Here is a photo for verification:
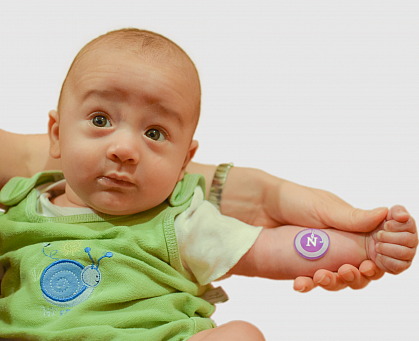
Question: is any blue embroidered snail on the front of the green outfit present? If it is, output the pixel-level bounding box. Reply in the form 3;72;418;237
41;247;113;307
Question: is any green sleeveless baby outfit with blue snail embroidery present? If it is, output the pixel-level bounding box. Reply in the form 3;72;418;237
0;172;215;341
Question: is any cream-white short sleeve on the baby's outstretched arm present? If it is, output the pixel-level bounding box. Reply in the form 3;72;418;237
175;187;262;285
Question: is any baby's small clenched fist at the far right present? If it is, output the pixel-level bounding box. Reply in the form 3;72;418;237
366;205;418;274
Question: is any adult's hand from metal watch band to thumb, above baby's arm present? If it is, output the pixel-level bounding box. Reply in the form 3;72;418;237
220;167;388;232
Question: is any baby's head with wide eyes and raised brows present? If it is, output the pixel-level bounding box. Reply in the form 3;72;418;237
49;29;201;215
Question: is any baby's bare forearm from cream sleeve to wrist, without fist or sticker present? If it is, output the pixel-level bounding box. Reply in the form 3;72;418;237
229;225;367;279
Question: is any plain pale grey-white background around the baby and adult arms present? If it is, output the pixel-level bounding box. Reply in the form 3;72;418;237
0;0;419;340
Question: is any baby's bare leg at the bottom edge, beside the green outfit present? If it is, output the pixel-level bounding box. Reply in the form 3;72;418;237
188;321;265;341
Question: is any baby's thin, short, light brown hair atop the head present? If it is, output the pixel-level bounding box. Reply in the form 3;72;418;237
58;28;201;117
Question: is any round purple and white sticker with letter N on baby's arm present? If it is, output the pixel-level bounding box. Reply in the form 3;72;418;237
294;229;330;260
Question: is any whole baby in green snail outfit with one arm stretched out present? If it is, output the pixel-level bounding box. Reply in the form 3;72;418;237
0;29;417;341
